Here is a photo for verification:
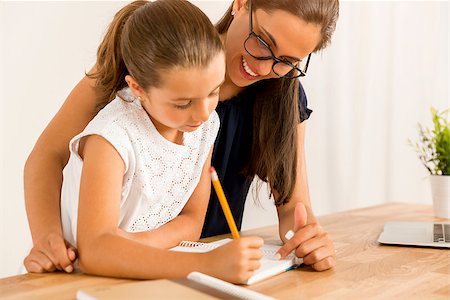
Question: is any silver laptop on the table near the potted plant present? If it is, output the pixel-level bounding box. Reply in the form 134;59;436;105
378;221;450;248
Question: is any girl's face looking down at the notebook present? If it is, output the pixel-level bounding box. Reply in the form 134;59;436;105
133;53;225;139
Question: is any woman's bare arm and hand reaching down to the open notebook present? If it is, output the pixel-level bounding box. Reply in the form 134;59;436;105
274;122;336;271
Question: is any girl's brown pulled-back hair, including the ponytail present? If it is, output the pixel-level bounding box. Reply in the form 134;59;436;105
87;0;223;108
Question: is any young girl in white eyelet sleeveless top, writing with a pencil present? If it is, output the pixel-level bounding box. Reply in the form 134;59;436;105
51;0;262;283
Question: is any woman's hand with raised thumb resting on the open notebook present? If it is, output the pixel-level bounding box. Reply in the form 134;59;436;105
278;203;336;271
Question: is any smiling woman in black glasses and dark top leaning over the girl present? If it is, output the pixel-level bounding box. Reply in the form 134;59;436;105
24;0;339;272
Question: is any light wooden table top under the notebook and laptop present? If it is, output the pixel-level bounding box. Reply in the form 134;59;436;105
0;204;450;300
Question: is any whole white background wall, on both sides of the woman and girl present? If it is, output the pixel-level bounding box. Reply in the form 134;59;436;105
0;1;449;277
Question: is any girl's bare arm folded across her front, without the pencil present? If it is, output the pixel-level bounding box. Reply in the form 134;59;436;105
117;148;212;248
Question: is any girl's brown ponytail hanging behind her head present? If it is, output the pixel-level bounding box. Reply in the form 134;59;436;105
86;1;148;109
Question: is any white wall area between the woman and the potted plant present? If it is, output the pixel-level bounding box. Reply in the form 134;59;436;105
303;1;450;214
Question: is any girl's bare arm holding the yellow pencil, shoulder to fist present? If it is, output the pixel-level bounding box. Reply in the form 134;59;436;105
77;135;262;283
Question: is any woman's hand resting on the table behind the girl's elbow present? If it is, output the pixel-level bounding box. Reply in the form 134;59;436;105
23;233;77;273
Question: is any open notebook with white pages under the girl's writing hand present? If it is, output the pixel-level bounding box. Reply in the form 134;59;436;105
171;238;302;285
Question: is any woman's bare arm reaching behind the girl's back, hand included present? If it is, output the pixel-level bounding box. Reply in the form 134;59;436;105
24;69;100;272
